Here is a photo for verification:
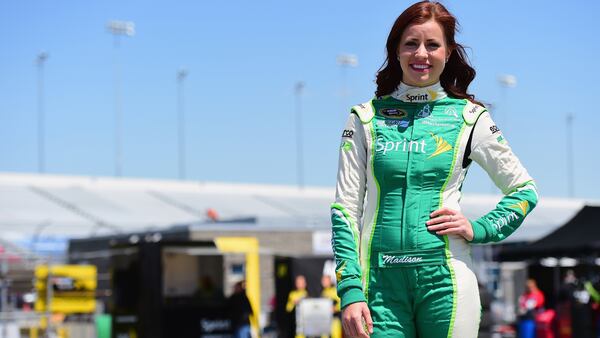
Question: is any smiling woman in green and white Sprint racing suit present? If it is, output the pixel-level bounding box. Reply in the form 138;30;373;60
331;1;537;338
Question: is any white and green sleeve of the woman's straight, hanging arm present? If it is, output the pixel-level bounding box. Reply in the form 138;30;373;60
331;113;367;308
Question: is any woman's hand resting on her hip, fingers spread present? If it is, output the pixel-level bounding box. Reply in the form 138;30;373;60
426;208;473;241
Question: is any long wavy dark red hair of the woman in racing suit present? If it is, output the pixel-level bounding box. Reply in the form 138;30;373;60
375;1;481;104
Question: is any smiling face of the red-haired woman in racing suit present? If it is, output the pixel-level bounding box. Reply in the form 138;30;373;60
398;20;450;87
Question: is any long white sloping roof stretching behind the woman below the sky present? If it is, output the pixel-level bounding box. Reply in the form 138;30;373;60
0;173;586;241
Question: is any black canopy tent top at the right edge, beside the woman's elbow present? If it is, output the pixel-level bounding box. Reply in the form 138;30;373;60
498;206;600;262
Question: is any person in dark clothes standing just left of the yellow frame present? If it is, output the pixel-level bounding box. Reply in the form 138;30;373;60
227;280;253;338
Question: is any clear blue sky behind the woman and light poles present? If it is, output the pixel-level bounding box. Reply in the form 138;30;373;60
0;0;600;199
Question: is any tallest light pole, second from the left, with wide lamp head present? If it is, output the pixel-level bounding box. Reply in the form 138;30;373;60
106;20;135;176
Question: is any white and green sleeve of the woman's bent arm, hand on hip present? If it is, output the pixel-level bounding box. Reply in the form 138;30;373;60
470;112;538;243
